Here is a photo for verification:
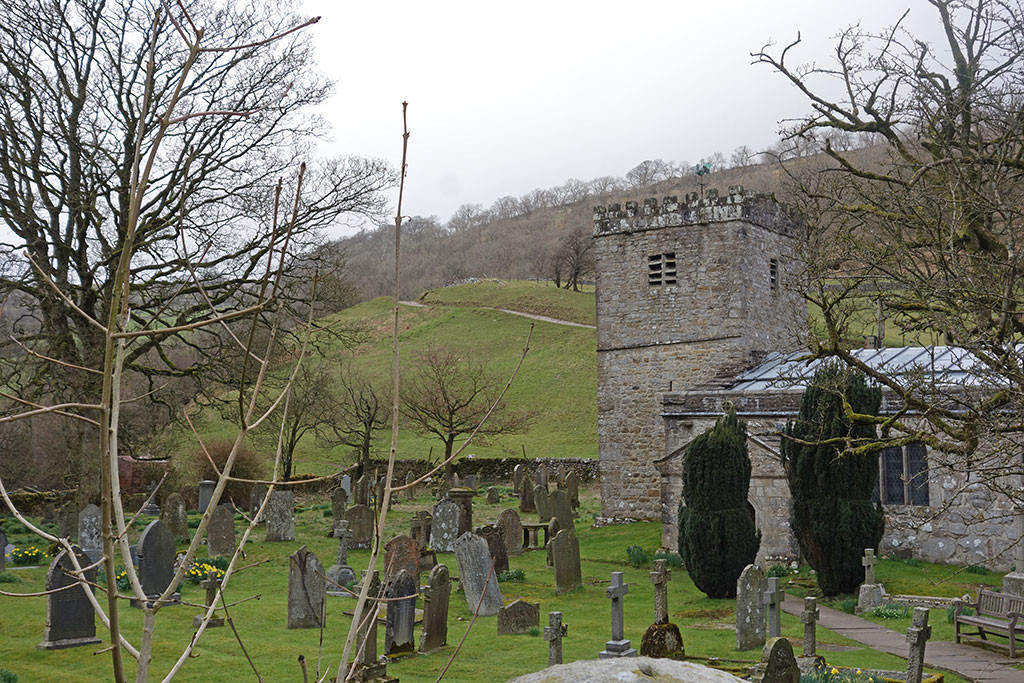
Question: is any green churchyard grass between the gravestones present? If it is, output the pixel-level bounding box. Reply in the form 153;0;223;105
0;486;975;683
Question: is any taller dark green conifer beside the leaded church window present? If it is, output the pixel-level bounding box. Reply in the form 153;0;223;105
781;364;885;596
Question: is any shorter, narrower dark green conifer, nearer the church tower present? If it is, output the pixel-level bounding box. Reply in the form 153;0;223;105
679;411;761;598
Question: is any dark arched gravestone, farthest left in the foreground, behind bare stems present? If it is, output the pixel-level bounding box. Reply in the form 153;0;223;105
36;547;101;650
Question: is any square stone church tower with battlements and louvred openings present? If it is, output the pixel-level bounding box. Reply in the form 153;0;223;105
594;186;807;519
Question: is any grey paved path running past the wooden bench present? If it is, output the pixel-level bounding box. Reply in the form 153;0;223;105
782;595;1024;683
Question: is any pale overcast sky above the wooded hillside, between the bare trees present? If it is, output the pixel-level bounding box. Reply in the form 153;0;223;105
303;0;935;237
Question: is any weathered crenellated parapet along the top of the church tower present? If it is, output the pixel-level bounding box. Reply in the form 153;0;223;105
594;185;802;237
